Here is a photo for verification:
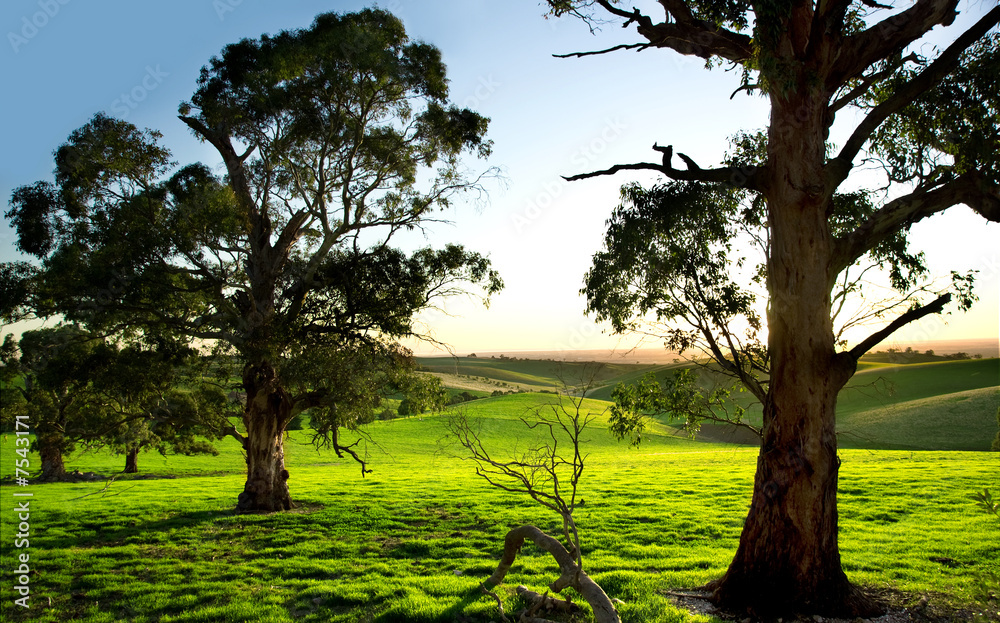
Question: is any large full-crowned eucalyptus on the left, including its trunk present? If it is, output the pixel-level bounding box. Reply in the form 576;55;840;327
2;9;501;511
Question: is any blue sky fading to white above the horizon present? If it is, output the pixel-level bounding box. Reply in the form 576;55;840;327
0;0;1000;352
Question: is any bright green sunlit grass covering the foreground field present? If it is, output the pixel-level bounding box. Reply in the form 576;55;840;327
0;396;1000;623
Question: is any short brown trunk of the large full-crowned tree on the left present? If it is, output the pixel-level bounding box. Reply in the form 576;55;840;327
236;361;294;512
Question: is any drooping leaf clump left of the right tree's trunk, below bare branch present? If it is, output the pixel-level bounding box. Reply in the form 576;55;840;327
583;183;756;342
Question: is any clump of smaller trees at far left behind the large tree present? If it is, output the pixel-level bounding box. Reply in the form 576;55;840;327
0;325;223;480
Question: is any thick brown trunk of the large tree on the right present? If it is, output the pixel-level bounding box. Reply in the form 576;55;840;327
709;87;874;616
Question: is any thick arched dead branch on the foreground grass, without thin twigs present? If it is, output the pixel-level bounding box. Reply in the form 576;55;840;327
483;525;621;623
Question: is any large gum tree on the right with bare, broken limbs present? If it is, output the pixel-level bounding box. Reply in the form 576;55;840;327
548;0;1000;616
